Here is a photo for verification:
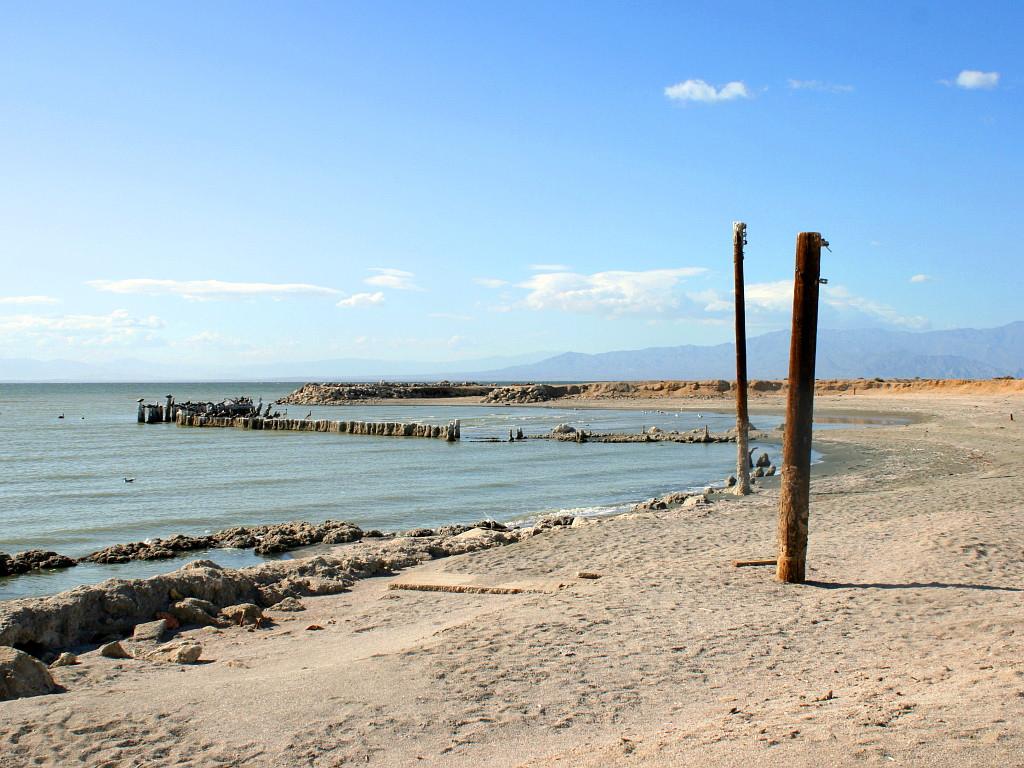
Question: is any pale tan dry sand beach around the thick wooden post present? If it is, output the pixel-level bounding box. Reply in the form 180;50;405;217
0;393;1024;768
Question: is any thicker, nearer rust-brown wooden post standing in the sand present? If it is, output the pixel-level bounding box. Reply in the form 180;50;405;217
775;232;822;584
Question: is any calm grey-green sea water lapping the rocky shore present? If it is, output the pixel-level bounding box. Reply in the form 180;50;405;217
0;383;779;599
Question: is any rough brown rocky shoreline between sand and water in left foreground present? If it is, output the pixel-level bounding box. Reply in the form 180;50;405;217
0;488;711;671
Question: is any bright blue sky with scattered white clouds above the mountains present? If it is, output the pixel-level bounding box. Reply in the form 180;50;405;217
0;2;1024;362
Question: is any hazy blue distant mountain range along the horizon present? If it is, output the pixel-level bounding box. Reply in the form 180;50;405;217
0;322;1024;381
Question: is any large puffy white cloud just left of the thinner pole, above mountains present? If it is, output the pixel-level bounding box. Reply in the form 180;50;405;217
519;267;708;314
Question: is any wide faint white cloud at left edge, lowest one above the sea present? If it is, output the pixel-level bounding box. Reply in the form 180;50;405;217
0;309;164;346
